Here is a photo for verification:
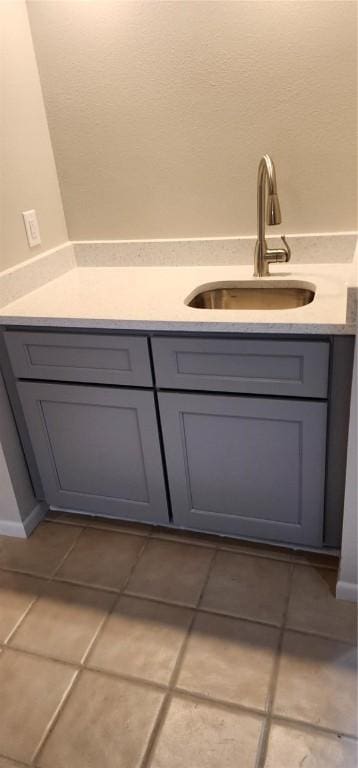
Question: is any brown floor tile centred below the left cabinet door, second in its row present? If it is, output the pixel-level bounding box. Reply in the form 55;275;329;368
56;526;146;589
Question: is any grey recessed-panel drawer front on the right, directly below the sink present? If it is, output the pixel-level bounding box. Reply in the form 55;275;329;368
152;337;329;398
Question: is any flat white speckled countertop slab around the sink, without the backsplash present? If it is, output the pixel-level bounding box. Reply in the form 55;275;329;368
0;262;356;334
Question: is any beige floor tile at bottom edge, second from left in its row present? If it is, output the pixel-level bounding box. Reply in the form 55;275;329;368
39;671;162;768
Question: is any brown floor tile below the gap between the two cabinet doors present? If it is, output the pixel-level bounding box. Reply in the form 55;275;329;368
127;539;213;606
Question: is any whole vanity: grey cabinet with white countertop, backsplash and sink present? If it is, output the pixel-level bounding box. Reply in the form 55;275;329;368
0;236;357;549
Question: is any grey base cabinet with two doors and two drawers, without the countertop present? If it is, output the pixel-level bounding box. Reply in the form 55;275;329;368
2;324;353;548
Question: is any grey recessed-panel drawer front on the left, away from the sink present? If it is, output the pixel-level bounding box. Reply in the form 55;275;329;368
5;331;152;387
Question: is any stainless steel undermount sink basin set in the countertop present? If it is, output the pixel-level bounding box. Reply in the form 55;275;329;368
185;281;315;310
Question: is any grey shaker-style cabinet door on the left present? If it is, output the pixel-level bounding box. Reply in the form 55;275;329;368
17;382;168;523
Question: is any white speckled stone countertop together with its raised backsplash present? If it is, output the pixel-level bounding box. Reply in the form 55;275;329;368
0;234;358;334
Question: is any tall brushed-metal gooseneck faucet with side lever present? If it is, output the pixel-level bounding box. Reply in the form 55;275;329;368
254;155;291;277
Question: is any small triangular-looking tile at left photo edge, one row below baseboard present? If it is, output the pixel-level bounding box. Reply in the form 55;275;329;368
0;571;44;643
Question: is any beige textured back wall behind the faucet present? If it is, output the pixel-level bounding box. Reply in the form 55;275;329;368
28;0;356;239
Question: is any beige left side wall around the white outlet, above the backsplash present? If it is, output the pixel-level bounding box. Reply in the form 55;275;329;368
0;0;68;270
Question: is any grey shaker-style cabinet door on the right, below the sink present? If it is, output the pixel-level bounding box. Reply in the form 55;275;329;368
159;393;326;546
